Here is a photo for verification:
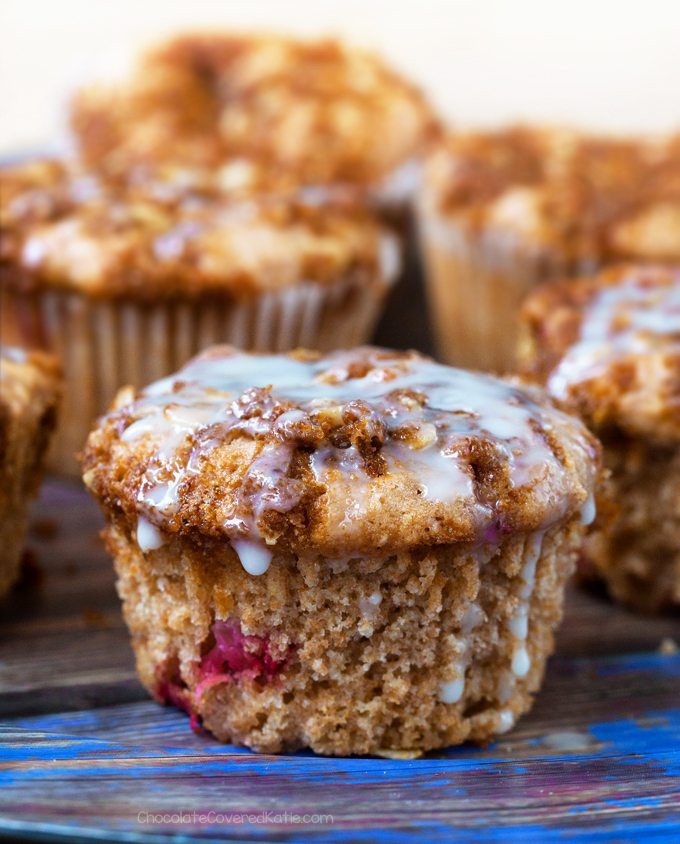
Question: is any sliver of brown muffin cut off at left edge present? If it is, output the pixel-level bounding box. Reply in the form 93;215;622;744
0;346;59;597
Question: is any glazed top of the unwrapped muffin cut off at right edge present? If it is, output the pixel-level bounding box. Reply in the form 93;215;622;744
521;265;680;442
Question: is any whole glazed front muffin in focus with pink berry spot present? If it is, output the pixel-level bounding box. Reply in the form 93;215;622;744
83;347;599;754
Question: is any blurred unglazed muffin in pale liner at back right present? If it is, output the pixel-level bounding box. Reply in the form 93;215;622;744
419;127;680;372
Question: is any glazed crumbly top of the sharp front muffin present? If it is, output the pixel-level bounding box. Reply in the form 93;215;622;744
83;346;599;573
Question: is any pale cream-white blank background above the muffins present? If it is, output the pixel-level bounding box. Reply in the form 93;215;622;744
0;0;680;152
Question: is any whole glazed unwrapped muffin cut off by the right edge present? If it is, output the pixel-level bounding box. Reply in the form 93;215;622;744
521;264;680;612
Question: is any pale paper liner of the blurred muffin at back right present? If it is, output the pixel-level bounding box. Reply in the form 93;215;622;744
418;211;576;372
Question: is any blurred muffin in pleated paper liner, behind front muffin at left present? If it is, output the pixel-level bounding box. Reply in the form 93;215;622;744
0;161;400;472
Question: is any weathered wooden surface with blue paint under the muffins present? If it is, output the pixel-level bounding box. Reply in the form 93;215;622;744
0;483;680;842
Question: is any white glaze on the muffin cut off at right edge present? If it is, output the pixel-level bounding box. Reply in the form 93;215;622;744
548;276;680;399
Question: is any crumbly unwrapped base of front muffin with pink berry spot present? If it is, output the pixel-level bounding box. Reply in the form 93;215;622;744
107;520;582;755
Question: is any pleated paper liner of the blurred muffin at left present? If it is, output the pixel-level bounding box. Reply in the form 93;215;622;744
2;271;395;475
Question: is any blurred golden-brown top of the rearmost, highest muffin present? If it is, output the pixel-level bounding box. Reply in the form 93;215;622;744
72;33;436;190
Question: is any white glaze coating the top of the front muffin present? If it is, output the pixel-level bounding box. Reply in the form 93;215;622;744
117;348;587;570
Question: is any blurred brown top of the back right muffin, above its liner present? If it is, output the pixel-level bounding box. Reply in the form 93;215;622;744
423;127;680;265
